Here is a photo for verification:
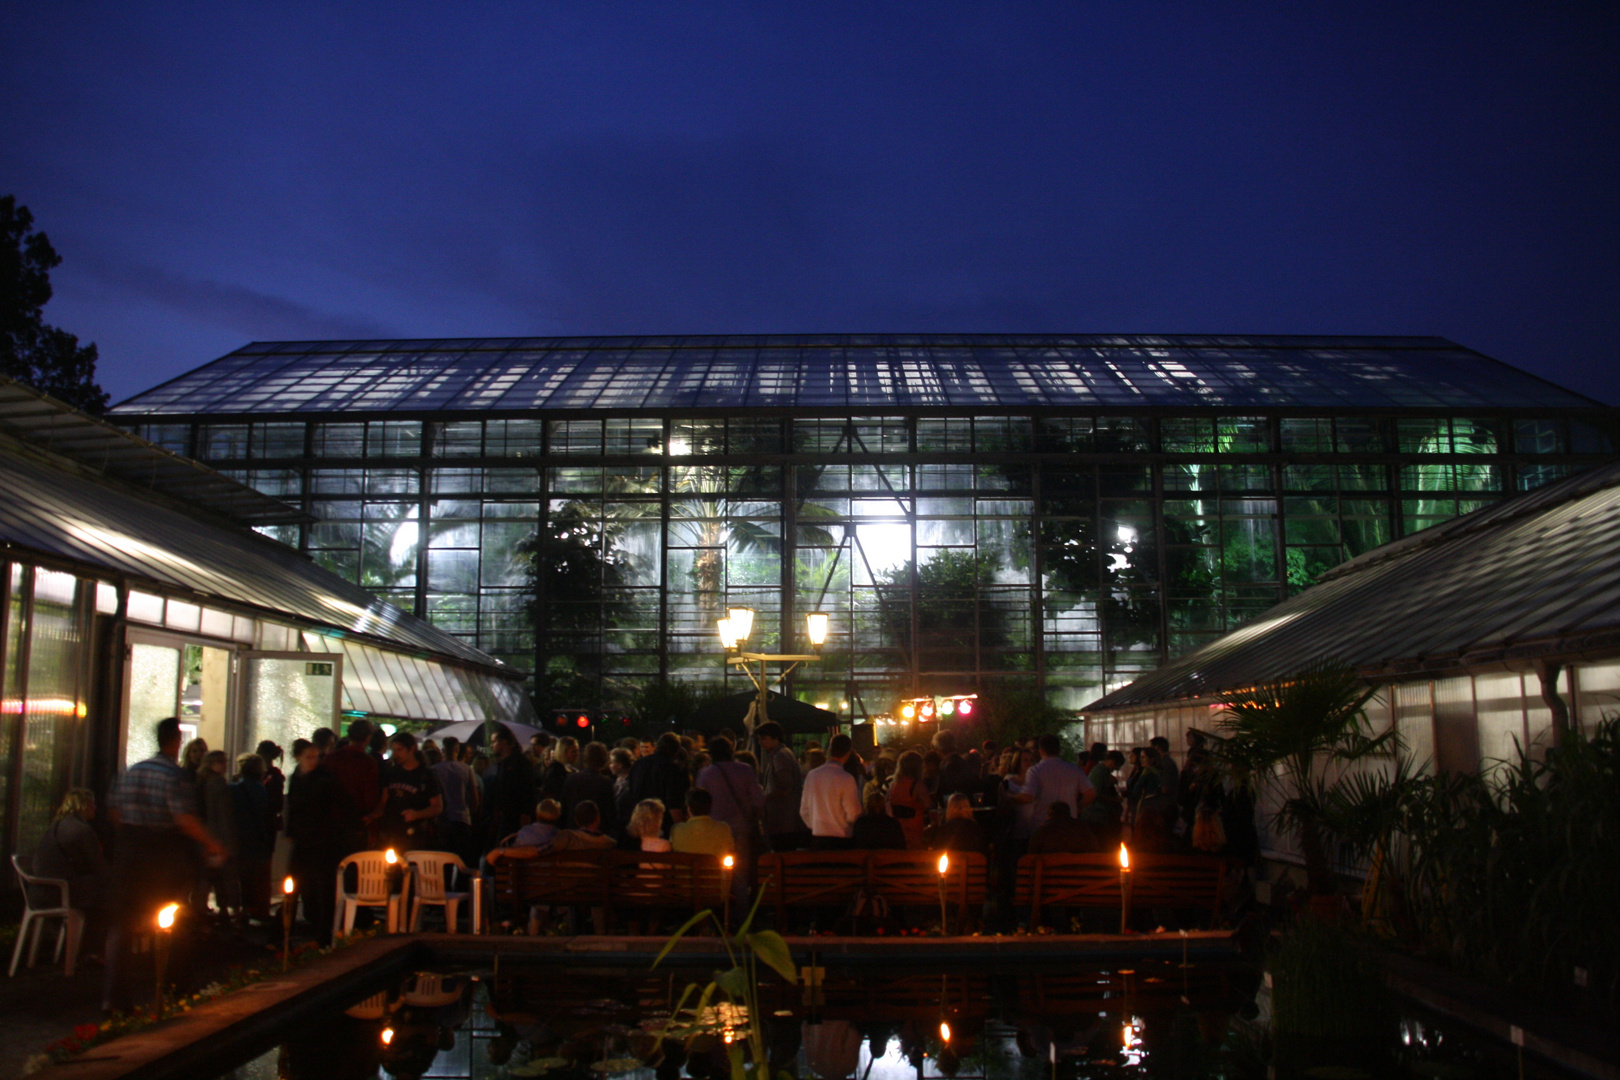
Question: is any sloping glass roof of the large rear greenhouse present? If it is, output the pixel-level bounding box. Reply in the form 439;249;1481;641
112;335;1597;416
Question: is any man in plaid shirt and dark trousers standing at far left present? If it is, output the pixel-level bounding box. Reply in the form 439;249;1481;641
102;716;225;1012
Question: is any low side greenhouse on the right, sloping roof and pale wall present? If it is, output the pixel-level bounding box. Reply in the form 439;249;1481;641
1085;463;1620;772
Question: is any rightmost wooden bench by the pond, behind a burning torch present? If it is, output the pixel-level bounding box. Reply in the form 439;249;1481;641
1013;852;1225;926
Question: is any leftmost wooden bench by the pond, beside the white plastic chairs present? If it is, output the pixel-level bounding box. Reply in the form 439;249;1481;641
494;848;729;913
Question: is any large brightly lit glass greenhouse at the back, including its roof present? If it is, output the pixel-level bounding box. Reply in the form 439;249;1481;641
112;335;1617;717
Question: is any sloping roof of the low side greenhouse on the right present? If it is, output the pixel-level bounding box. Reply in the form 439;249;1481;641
1084;463;1620;712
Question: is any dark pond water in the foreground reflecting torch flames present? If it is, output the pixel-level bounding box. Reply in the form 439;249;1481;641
220;960;1560;1080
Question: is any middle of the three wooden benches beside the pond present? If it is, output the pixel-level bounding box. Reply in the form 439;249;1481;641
755;852;987;926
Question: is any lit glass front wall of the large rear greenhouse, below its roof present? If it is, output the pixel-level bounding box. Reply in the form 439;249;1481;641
144;410;1610;711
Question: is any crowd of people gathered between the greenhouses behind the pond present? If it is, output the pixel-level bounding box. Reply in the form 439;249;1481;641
34;717;1259;1009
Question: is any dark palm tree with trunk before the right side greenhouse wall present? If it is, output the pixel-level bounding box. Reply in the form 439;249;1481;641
1205;661;1396;895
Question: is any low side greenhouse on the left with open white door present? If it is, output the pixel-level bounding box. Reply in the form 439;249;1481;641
0;377;533;882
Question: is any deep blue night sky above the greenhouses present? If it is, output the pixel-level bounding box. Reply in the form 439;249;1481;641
0;0;1620;403
